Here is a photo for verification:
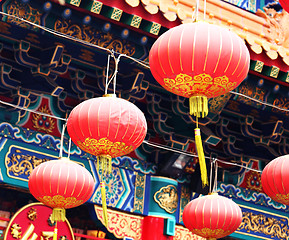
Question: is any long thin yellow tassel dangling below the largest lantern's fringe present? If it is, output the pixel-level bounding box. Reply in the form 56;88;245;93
195;128;208;187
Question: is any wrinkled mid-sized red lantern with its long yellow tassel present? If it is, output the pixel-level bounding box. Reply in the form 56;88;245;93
67;94;147;226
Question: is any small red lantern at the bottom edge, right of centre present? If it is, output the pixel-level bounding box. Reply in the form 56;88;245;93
183;193;242;239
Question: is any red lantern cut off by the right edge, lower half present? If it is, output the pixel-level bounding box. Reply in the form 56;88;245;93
261;155;289;205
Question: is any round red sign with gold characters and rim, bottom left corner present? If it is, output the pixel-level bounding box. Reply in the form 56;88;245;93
4;203;74;240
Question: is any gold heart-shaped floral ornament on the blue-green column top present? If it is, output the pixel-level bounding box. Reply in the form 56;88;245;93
154;185;178;213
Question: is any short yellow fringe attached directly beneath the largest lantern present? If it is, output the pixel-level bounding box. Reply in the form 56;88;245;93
190;96;209;118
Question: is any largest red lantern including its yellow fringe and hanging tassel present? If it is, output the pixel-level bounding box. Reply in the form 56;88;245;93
149;22;250;185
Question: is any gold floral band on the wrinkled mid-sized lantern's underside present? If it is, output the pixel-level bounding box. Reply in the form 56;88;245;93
77;137;133;158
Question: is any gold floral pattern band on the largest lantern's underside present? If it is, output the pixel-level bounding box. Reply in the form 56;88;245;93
164;73;236;98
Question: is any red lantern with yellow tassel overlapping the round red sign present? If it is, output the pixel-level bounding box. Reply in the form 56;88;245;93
28;158;95;238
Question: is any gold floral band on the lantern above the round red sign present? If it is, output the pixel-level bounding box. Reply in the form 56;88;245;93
37;195;83;208
